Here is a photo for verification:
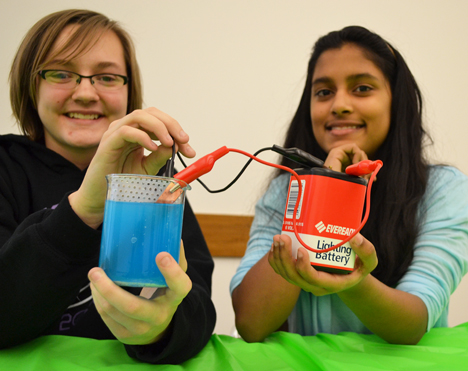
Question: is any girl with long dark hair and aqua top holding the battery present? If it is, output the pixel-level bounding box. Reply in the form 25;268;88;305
231;26;468;344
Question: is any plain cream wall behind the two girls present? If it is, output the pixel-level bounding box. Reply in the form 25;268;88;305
0;0;468;333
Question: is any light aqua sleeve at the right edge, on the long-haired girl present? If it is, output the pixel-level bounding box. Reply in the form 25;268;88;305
397;167;468;330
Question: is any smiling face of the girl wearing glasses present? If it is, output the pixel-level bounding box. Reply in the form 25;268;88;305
37;25;128;168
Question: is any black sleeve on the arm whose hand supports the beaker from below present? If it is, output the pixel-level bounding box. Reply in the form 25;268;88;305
125;202;216;364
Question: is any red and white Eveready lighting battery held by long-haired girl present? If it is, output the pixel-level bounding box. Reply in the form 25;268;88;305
282;168;367;274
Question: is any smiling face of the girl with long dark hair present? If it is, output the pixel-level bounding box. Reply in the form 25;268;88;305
310;44;392;158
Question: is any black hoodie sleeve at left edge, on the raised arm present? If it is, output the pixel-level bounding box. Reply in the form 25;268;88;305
0;195;101;348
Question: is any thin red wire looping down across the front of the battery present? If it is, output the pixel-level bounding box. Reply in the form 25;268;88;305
228;148;382;253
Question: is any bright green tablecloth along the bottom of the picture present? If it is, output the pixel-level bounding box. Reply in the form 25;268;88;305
0;323;468;371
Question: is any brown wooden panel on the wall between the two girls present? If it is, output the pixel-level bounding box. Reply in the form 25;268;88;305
196;214;253;257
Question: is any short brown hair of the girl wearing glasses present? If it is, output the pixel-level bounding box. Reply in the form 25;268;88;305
10;9;143;142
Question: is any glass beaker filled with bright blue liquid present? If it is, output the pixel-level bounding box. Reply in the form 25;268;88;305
99;174;190;287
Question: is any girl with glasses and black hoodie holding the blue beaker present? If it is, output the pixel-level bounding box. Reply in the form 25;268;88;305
0;9;216;363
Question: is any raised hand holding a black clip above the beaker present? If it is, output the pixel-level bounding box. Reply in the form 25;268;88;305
69;107;195;228
